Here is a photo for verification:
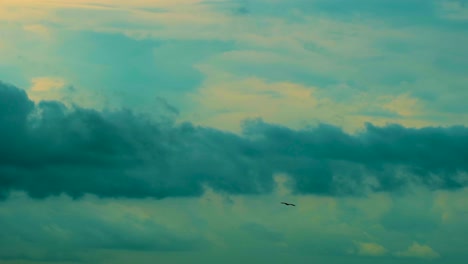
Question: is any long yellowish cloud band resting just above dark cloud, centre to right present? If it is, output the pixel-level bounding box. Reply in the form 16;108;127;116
186;71;434;133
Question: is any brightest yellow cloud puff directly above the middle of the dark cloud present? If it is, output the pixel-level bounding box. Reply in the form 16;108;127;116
186;77;317;134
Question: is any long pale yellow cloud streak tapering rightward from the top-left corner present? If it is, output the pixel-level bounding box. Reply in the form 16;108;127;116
0;0;409;51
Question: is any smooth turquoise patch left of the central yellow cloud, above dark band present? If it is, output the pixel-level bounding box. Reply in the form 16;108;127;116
46;32;233;113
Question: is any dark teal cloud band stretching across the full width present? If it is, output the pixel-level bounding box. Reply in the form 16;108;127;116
0;83;468;198
